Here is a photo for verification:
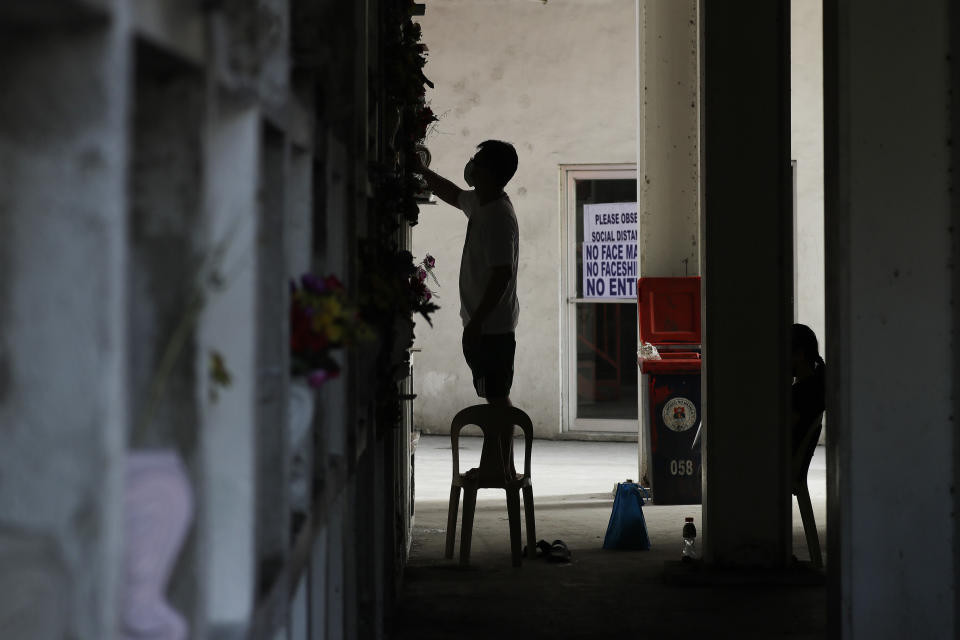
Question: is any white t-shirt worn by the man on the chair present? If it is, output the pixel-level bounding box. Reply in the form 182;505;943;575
457;191;520;333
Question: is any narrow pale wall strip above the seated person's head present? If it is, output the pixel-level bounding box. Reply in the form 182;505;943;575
790;0;826;354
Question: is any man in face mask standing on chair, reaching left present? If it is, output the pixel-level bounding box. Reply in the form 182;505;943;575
421;140;520;477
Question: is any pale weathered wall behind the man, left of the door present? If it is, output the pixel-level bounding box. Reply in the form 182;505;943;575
414;0;637;437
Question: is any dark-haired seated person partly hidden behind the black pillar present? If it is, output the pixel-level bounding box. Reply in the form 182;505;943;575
790;324;826;459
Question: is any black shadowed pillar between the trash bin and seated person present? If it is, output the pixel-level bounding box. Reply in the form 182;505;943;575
701;0;793;568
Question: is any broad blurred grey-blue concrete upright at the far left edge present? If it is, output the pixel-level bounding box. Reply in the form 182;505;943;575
0;7;131;639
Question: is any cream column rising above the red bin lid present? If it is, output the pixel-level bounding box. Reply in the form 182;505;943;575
637;0;700;276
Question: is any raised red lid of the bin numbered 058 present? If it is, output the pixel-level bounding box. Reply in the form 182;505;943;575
637;276;700;344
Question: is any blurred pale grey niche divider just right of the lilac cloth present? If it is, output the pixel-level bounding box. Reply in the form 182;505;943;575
197;100;261;638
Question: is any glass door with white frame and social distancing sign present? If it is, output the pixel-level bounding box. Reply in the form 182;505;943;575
563;165;639;433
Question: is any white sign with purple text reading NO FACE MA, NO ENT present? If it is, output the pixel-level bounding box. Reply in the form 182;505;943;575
583;202;637;298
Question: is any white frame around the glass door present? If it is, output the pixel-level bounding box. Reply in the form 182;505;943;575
559;162;640;434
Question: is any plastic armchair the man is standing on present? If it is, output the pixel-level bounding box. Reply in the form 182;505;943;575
446;404;537;567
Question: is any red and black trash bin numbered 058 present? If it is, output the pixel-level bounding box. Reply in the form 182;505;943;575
637;277;702;504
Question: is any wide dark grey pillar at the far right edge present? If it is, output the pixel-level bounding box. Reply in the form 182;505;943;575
824;0;960;640
